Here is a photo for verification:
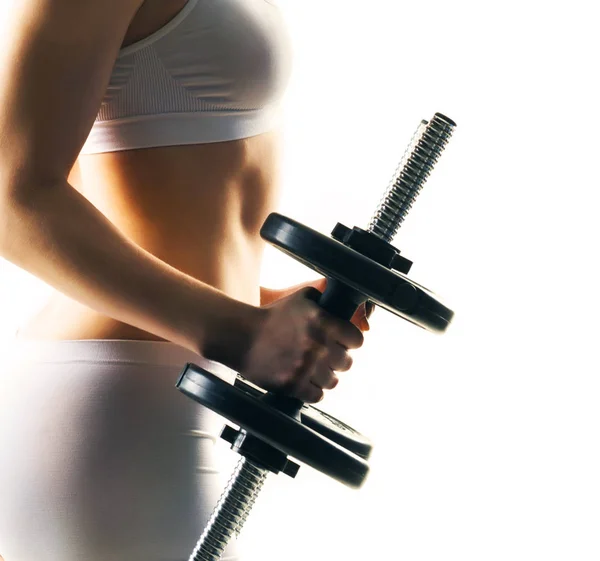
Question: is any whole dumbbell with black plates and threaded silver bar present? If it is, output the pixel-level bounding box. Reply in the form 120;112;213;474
176;113;456;561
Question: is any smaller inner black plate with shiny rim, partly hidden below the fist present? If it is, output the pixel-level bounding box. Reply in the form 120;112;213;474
235;377;373;460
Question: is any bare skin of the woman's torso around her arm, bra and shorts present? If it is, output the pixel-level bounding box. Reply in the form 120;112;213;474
18;0;279;340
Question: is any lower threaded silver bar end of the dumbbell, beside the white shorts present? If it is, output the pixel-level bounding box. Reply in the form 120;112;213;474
189;457;269;561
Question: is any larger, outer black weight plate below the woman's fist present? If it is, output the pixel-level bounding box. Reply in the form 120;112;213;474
176;363;369;488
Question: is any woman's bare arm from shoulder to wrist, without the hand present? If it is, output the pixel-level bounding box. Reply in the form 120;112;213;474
0;0;262;370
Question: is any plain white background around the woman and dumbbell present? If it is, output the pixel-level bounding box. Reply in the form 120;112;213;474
0;0;600;561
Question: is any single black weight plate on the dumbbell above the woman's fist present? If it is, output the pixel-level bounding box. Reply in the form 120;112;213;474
260;213;454;333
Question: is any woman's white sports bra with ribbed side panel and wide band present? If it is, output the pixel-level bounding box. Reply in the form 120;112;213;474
81;0;292;154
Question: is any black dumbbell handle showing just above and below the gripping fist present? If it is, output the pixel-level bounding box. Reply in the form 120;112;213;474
263;278;367;420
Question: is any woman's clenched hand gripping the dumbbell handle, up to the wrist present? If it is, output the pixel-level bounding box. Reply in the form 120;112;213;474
240;286;364;403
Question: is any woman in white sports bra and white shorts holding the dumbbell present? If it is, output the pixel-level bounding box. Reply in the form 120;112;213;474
0;0;368;561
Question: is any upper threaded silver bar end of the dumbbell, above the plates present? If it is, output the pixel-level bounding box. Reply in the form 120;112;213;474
369;113;456;243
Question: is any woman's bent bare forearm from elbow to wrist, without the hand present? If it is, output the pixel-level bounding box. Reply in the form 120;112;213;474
0;177;257;369
